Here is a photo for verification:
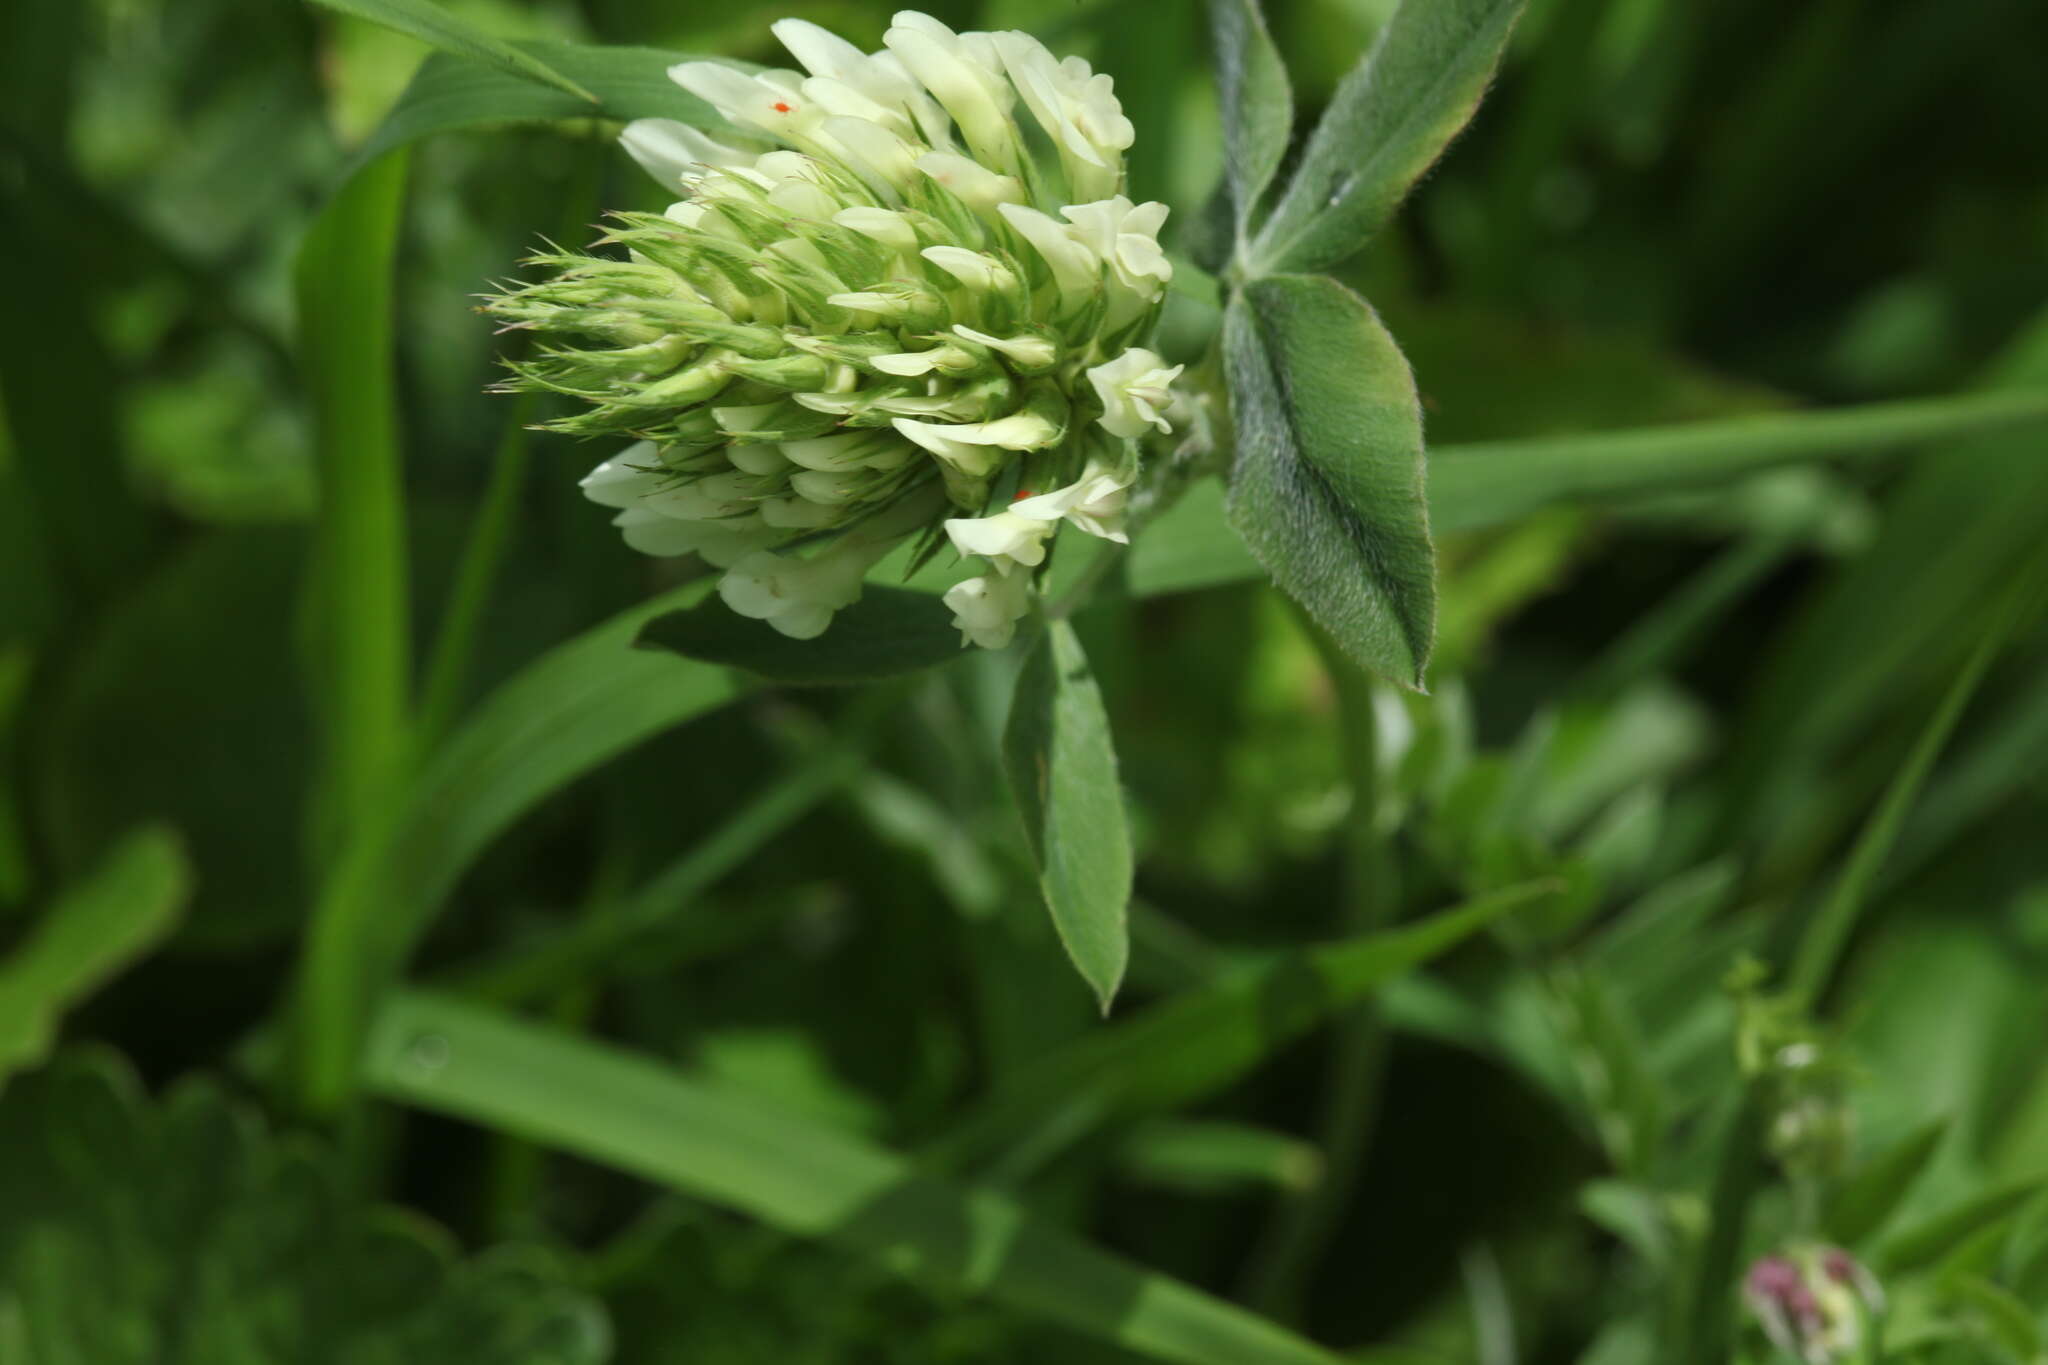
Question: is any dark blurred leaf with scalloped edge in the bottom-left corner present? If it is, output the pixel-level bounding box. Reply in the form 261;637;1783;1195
0;1054;610;1365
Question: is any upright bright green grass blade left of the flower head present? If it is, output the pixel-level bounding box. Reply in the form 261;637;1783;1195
297;153;412;847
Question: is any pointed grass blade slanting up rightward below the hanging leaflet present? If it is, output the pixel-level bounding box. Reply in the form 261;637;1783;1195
940;882;1559;1160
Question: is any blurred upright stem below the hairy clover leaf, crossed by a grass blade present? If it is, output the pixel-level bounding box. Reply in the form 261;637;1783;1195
1245;618;1401;1316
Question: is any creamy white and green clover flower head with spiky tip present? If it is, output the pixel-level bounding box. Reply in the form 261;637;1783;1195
485;10;1180;649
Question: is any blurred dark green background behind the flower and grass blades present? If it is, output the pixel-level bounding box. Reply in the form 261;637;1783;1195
0;0;2048;1365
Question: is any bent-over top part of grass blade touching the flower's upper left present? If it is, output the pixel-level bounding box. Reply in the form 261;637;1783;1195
356;43;727;166
